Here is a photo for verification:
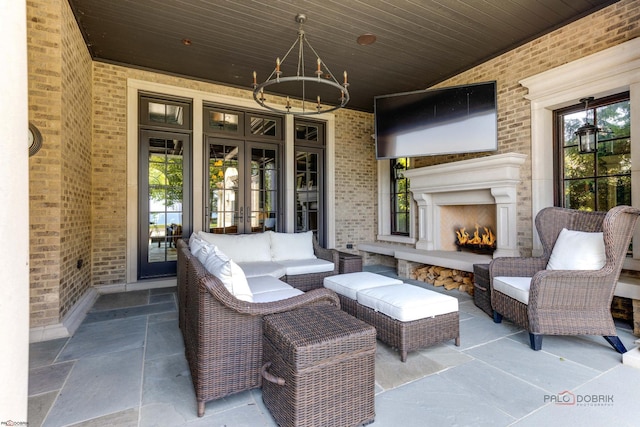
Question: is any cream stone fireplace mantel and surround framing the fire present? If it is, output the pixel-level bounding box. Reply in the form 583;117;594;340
405;153;527;258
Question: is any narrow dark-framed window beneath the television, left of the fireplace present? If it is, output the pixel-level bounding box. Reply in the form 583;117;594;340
390;157;411;236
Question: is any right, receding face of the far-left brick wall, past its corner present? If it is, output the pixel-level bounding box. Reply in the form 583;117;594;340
60;2;92;317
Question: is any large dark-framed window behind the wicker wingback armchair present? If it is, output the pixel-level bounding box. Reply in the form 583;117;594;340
554;92;631;211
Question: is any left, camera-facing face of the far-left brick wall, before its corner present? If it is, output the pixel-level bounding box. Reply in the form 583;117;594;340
27;1;62;326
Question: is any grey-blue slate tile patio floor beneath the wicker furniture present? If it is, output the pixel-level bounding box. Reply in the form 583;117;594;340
29;267;640;427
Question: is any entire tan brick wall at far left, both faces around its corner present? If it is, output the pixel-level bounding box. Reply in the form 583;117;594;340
27;0;91;327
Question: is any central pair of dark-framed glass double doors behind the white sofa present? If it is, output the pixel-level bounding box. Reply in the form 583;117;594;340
205;136;282;234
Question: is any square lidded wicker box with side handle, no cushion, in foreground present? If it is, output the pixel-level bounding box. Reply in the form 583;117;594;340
262;306;376;427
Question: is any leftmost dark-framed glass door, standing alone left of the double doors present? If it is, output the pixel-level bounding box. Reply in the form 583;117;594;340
138;130;192;279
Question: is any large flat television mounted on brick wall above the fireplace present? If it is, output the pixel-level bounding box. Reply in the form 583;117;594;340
374;81;498;159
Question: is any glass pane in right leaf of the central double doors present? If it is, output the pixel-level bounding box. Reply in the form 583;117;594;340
247;144;280;233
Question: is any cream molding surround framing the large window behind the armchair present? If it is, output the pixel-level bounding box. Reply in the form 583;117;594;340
519;38;640;269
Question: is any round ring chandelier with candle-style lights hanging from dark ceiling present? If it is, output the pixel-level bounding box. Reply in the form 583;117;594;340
253;13;349;116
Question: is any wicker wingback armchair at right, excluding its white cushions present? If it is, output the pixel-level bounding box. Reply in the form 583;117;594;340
489;206;640;353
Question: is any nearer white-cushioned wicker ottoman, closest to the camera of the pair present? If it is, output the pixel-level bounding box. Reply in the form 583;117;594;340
357;284;460;362
